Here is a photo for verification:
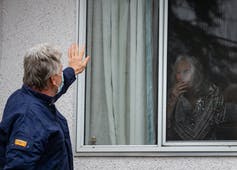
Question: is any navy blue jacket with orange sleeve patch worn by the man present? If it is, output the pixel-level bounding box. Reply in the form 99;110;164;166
0;67;76;170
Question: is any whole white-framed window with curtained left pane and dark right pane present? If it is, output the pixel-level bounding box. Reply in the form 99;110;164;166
76;0;237;155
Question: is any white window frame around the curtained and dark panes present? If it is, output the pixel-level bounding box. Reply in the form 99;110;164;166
74;0;237;156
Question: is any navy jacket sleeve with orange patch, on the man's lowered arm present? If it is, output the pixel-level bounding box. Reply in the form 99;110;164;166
4;115;44;170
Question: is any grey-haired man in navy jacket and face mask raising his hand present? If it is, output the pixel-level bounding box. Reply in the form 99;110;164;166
0;44;90;170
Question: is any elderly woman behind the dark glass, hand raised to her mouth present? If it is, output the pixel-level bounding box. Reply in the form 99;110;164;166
167;55;225;140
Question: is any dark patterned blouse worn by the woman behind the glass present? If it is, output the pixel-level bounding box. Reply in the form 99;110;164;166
171;84;225;140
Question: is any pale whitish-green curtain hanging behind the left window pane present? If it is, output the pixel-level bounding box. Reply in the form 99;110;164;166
85;0;155;145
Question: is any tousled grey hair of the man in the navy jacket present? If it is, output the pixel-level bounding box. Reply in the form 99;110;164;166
23;43;62;90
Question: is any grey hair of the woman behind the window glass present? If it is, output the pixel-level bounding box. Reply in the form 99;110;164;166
172;55;206;93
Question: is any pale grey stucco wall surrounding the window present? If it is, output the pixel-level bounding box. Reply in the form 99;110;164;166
0;0;237;170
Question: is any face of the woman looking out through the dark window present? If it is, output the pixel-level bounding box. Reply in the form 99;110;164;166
175;60;193;83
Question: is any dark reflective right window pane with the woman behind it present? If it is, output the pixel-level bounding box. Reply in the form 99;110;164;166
166;0;237;141
